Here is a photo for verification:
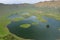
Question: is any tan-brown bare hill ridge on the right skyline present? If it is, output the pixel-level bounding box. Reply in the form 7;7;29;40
34;1;60;7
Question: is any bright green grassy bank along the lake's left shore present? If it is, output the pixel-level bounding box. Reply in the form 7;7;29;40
0;17;10;36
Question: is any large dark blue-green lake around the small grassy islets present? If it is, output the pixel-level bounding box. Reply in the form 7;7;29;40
7;16;60;40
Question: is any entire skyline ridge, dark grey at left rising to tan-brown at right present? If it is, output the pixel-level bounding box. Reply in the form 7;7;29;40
0;1;60;7
